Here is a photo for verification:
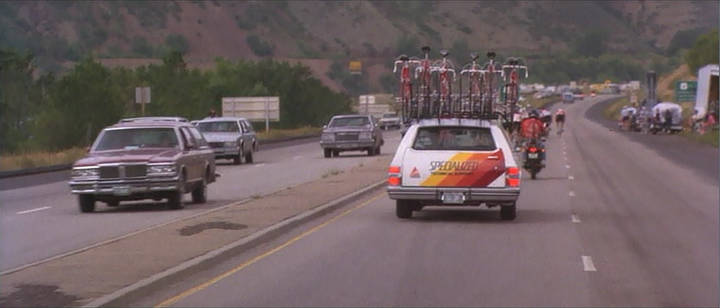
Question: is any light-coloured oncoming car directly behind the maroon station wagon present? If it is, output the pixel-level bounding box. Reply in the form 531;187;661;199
197;117;259;165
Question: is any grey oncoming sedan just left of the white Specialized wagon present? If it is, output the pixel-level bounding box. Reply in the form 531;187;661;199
320;115;385;158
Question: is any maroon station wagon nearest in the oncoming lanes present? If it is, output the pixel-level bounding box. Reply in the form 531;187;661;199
69;121;216;212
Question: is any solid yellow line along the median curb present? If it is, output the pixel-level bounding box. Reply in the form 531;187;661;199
155;192;385;307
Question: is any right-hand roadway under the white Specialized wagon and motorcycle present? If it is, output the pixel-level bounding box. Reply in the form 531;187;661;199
132;98;720;307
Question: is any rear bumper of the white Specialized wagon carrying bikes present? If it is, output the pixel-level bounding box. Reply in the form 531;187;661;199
387;186;520;203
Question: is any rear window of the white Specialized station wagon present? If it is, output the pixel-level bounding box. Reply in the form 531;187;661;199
413;127;496;151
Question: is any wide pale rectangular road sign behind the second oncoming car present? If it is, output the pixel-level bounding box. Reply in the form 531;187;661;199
222;96;280;131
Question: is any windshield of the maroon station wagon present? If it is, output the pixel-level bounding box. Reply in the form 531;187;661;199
95;127;178;151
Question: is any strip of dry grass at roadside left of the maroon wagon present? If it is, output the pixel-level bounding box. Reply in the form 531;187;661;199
0;148;86;171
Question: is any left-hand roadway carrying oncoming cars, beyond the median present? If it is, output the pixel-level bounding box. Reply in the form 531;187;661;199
0;131;400;271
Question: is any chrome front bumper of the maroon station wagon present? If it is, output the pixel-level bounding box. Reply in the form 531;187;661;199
70;177;179;196
